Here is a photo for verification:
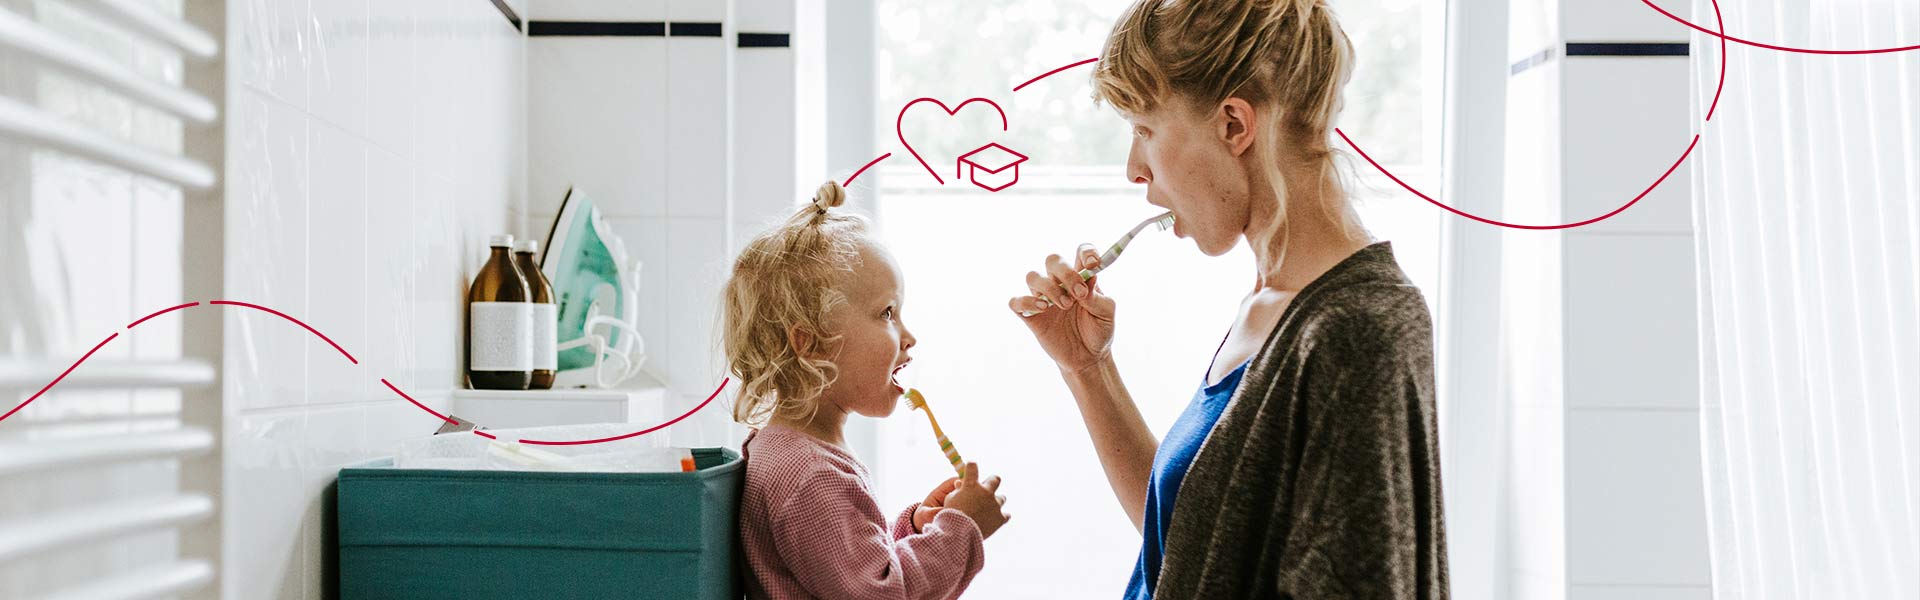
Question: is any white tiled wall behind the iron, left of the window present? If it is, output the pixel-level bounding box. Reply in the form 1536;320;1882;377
526;0;822;446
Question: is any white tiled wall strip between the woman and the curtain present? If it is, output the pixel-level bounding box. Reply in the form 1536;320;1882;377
1503;0;1711;598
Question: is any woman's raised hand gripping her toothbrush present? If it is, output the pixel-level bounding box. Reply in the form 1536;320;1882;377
1008;244;1114;373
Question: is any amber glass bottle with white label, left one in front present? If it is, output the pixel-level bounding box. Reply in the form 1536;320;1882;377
467;235;534;390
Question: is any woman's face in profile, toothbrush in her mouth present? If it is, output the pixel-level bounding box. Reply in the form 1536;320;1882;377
1125;98;1252;256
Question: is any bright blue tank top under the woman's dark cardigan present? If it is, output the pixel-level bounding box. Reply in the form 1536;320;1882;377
1125;362;1252;600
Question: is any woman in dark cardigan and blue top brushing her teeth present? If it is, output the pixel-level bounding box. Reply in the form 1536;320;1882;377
1008;0;1448;598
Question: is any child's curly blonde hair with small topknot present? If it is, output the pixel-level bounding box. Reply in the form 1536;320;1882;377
722;181;870;427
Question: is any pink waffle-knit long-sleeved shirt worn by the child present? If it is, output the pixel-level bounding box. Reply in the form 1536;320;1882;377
739;425;985;600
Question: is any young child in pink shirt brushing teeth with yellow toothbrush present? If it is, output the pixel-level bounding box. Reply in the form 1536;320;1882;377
724;181;1008;598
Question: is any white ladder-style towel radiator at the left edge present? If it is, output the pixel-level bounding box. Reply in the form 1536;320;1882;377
0;0;227;598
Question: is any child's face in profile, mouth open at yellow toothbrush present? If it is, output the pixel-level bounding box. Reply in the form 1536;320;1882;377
824;244;914;417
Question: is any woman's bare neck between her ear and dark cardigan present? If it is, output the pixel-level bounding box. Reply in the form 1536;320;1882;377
1246;171;1373;292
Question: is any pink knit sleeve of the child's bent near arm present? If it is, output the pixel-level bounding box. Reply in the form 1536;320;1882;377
772;477;985;600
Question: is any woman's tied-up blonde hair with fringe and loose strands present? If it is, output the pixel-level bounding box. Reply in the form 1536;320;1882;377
1092;0;1365;265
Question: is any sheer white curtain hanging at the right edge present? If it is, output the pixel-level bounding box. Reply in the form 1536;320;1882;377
1676;0;1920;598
